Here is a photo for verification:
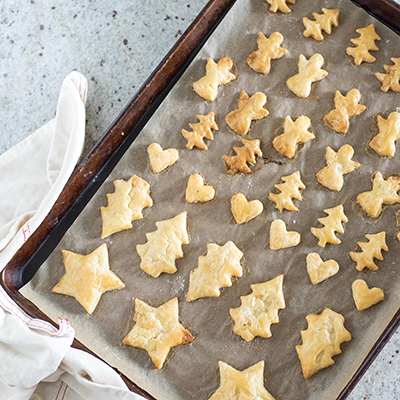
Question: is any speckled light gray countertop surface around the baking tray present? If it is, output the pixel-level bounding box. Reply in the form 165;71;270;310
0;0;400;400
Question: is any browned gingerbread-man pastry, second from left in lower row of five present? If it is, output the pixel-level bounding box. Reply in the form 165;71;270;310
225;90;269;135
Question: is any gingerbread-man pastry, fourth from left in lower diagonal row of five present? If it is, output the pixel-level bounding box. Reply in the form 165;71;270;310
317;144;360;192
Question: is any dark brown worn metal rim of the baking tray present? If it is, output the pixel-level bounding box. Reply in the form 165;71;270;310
0;0;400;400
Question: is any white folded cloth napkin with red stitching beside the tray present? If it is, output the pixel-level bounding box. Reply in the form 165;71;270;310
0;72;143;400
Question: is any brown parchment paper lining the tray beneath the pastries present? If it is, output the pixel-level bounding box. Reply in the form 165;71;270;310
22;0;400;400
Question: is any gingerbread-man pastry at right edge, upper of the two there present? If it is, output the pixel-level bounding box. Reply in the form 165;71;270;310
369;112;400;157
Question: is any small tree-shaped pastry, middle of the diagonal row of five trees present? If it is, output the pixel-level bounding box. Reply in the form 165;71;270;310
268;171;306;212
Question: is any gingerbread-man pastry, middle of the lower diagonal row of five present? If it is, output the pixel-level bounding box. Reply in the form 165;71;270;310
272;115;315;158
